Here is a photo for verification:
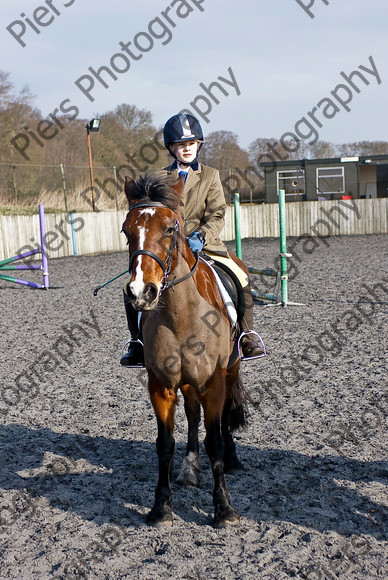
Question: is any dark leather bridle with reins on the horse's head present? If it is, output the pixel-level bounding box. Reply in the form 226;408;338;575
122;201;199;292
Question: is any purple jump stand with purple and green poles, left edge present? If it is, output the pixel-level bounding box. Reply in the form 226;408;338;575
0;205;49;290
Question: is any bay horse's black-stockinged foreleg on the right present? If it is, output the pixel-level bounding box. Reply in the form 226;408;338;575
200;368;240;527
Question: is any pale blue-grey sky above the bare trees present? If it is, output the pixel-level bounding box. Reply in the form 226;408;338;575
0;0;388;148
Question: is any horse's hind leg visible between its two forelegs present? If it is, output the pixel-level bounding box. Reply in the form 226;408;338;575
177;385;201;487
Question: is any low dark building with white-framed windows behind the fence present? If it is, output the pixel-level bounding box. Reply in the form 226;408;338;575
261;155;388;203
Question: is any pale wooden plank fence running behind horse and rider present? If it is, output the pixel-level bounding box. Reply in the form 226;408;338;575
0;198;388;260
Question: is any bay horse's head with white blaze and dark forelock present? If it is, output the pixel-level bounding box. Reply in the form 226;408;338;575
122;174;183;310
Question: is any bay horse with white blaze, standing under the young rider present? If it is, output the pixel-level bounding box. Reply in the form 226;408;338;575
122;173;246;527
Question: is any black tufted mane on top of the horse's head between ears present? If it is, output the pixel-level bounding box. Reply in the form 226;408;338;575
126;173;179;211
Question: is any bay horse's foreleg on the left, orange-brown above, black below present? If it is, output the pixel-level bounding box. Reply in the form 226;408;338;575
147;377;177;526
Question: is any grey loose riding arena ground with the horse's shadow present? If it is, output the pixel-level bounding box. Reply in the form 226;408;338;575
0;236;388;580
